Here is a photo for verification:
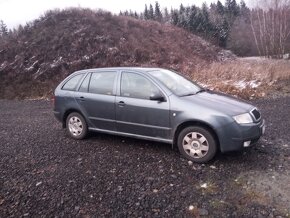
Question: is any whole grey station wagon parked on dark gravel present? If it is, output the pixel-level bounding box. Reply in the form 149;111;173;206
54;68;265;163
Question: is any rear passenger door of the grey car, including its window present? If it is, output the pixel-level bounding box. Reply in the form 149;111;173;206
75;71;117;131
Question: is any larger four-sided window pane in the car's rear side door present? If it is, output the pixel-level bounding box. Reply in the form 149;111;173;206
89;72;116;95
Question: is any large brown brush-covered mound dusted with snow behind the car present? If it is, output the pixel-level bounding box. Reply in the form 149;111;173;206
0;9;228;98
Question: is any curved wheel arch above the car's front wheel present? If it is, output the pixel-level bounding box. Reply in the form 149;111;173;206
173;120;220;150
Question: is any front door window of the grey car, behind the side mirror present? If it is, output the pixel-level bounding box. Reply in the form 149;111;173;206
121;73;160;99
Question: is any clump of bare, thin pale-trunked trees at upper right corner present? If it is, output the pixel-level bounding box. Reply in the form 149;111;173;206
250;0;290;58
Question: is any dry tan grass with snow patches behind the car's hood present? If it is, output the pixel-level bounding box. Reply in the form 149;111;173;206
192;58;290;99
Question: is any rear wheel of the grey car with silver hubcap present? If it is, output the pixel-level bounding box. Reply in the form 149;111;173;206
66;112;88;140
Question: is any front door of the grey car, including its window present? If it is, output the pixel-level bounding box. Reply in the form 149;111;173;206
116;72;171;139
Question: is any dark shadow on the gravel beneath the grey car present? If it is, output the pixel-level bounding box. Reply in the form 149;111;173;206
65;132;269;168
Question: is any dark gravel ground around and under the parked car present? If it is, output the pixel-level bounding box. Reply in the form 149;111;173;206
0;97;290;217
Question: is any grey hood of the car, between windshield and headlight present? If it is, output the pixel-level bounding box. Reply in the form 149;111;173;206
184;92;254;116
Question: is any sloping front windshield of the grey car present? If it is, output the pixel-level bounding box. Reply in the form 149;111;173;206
148;69;202;96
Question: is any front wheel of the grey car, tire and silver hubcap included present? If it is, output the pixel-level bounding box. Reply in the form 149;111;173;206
177;126;217;163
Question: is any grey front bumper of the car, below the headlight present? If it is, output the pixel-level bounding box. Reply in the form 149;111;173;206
217;119;265;152
